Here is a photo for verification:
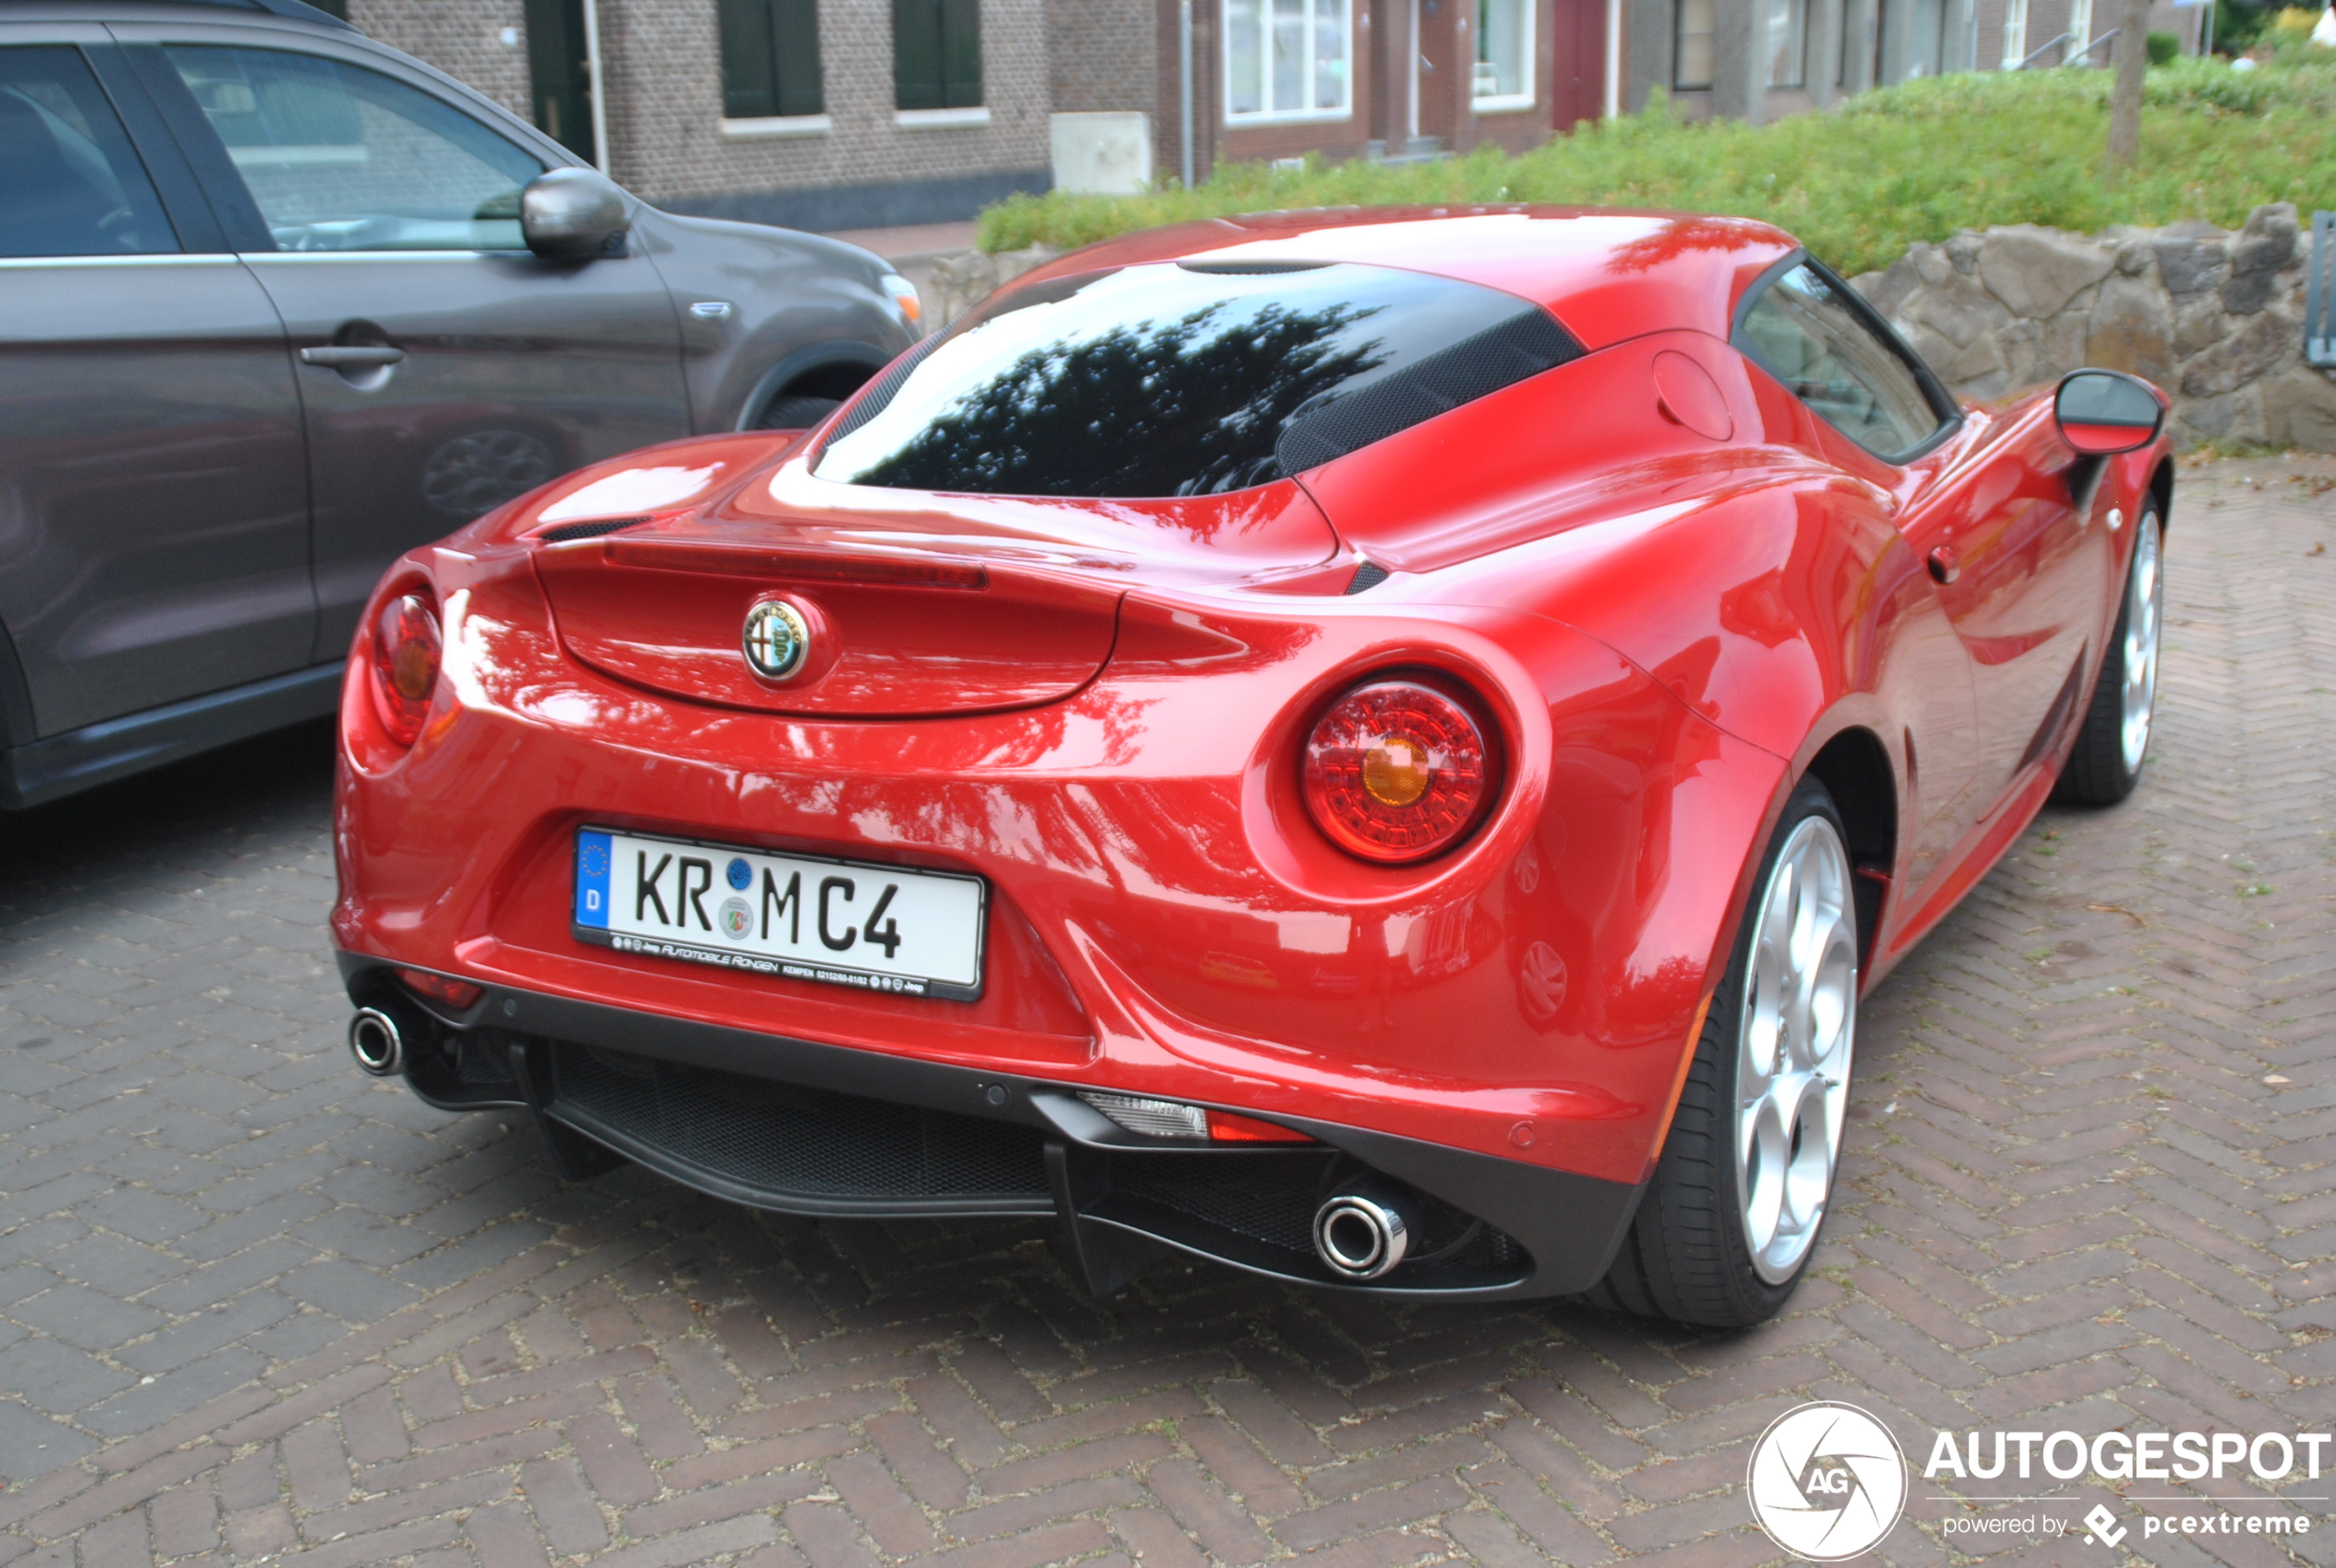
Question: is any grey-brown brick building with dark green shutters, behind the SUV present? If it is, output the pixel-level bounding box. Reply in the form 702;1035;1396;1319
334;0;1051;229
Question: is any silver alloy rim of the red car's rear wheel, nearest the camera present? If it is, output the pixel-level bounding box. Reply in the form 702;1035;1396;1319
1735;816;1857;1286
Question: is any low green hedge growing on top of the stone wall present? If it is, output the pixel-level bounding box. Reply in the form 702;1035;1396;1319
979;61;2336;273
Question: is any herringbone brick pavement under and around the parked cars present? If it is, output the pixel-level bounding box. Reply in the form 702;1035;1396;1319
0;463;2336;1568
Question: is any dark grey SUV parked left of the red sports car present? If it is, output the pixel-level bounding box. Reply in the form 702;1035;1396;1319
0;0;916;807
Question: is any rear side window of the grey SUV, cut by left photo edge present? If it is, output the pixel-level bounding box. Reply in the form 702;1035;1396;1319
0;44;177;258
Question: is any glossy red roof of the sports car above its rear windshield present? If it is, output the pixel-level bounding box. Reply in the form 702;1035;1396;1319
1024;206;1799;349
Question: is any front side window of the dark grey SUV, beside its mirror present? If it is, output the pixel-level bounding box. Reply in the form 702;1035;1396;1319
168;44;544;250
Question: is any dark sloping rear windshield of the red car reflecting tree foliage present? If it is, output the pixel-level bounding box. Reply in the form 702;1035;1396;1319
815;262;1582;498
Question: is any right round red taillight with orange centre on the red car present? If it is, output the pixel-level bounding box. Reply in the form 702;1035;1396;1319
1306;680;1497;864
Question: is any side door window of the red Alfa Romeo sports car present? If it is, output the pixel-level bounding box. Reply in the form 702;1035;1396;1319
1735;262;1941;461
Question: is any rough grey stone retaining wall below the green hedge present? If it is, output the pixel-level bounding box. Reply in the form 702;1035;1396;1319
932;203;2336;451
